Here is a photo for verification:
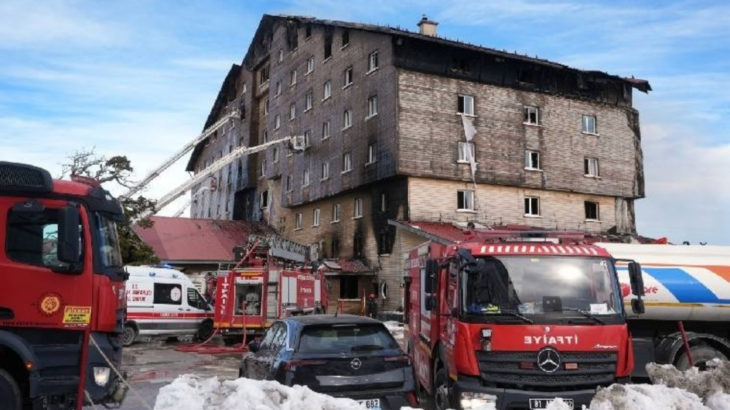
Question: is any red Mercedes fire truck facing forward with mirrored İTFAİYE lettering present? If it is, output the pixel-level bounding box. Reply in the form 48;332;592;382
405;232;644;409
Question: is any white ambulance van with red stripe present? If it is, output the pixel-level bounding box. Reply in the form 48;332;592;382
123;266;213;346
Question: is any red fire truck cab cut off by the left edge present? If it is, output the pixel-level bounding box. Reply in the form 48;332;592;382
0;162;126;410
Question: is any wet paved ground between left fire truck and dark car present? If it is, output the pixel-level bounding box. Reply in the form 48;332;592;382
85;341;241;410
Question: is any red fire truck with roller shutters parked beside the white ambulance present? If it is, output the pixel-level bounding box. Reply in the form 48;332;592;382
214;237;327;344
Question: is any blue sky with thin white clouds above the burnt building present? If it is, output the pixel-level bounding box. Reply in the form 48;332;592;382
0;0;730;245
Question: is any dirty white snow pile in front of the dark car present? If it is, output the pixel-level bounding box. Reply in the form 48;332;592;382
155;375;365;410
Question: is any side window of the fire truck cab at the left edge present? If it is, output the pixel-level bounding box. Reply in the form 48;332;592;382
5;209;84;269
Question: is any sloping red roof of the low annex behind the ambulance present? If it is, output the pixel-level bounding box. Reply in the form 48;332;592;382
134;216;273;262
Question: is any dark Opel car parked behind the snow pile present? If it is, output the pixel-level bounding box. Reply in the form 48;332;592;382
240;315;416;410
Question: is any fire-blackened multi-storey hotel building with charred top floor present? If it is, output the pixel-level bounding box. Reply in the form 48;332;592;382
188;15;651;310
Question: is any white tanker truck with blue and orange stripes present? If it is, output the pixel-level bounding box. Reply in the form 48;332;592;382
596;243;730;378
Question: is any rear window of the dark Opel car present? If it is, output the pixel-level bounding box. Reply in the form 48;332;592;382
299;324;398;353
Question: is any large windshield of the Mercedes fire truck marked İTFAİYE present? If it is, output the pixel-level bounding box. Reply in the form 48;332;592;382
461;256;621;320
